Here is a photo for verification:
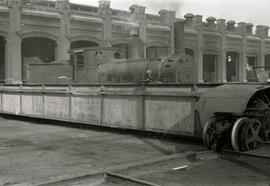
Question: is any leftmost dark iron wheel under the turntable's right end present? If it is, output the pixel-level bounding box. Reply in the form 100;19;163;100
203;118;217;150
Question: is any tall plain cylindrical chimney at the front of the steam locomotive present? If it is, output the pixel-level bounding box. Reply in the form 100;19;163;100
174;21;185;54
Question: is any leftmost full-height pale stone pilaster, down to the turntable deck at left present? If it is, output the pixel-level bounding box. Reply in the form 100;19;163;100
5;0;22;83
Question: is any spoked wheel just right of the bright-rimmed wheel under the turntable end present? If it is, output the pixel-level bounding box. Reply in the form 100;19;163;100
240;119;262;151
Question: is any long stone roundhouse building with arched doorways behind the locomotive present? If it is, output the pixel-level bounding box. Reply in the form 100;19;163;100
0;0;270;83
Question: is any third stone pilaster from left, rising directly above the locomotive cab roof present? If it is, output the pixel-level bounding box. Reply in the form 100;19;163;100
99;0;112;47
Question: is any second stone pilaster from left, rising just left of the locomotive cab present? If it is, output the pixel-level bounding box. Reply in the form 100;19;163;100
57;0;70;63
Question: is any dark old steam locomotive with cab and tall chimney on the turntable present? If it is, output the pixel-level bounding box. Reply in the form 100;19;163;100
70;21;197;83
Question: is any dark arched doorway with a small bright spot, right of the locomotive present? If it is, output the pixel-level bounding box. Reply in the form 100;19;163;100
226;51;239;82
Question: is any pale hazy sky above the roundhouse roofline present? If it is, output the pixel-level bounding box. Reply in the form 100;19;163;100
70;0;270;26
